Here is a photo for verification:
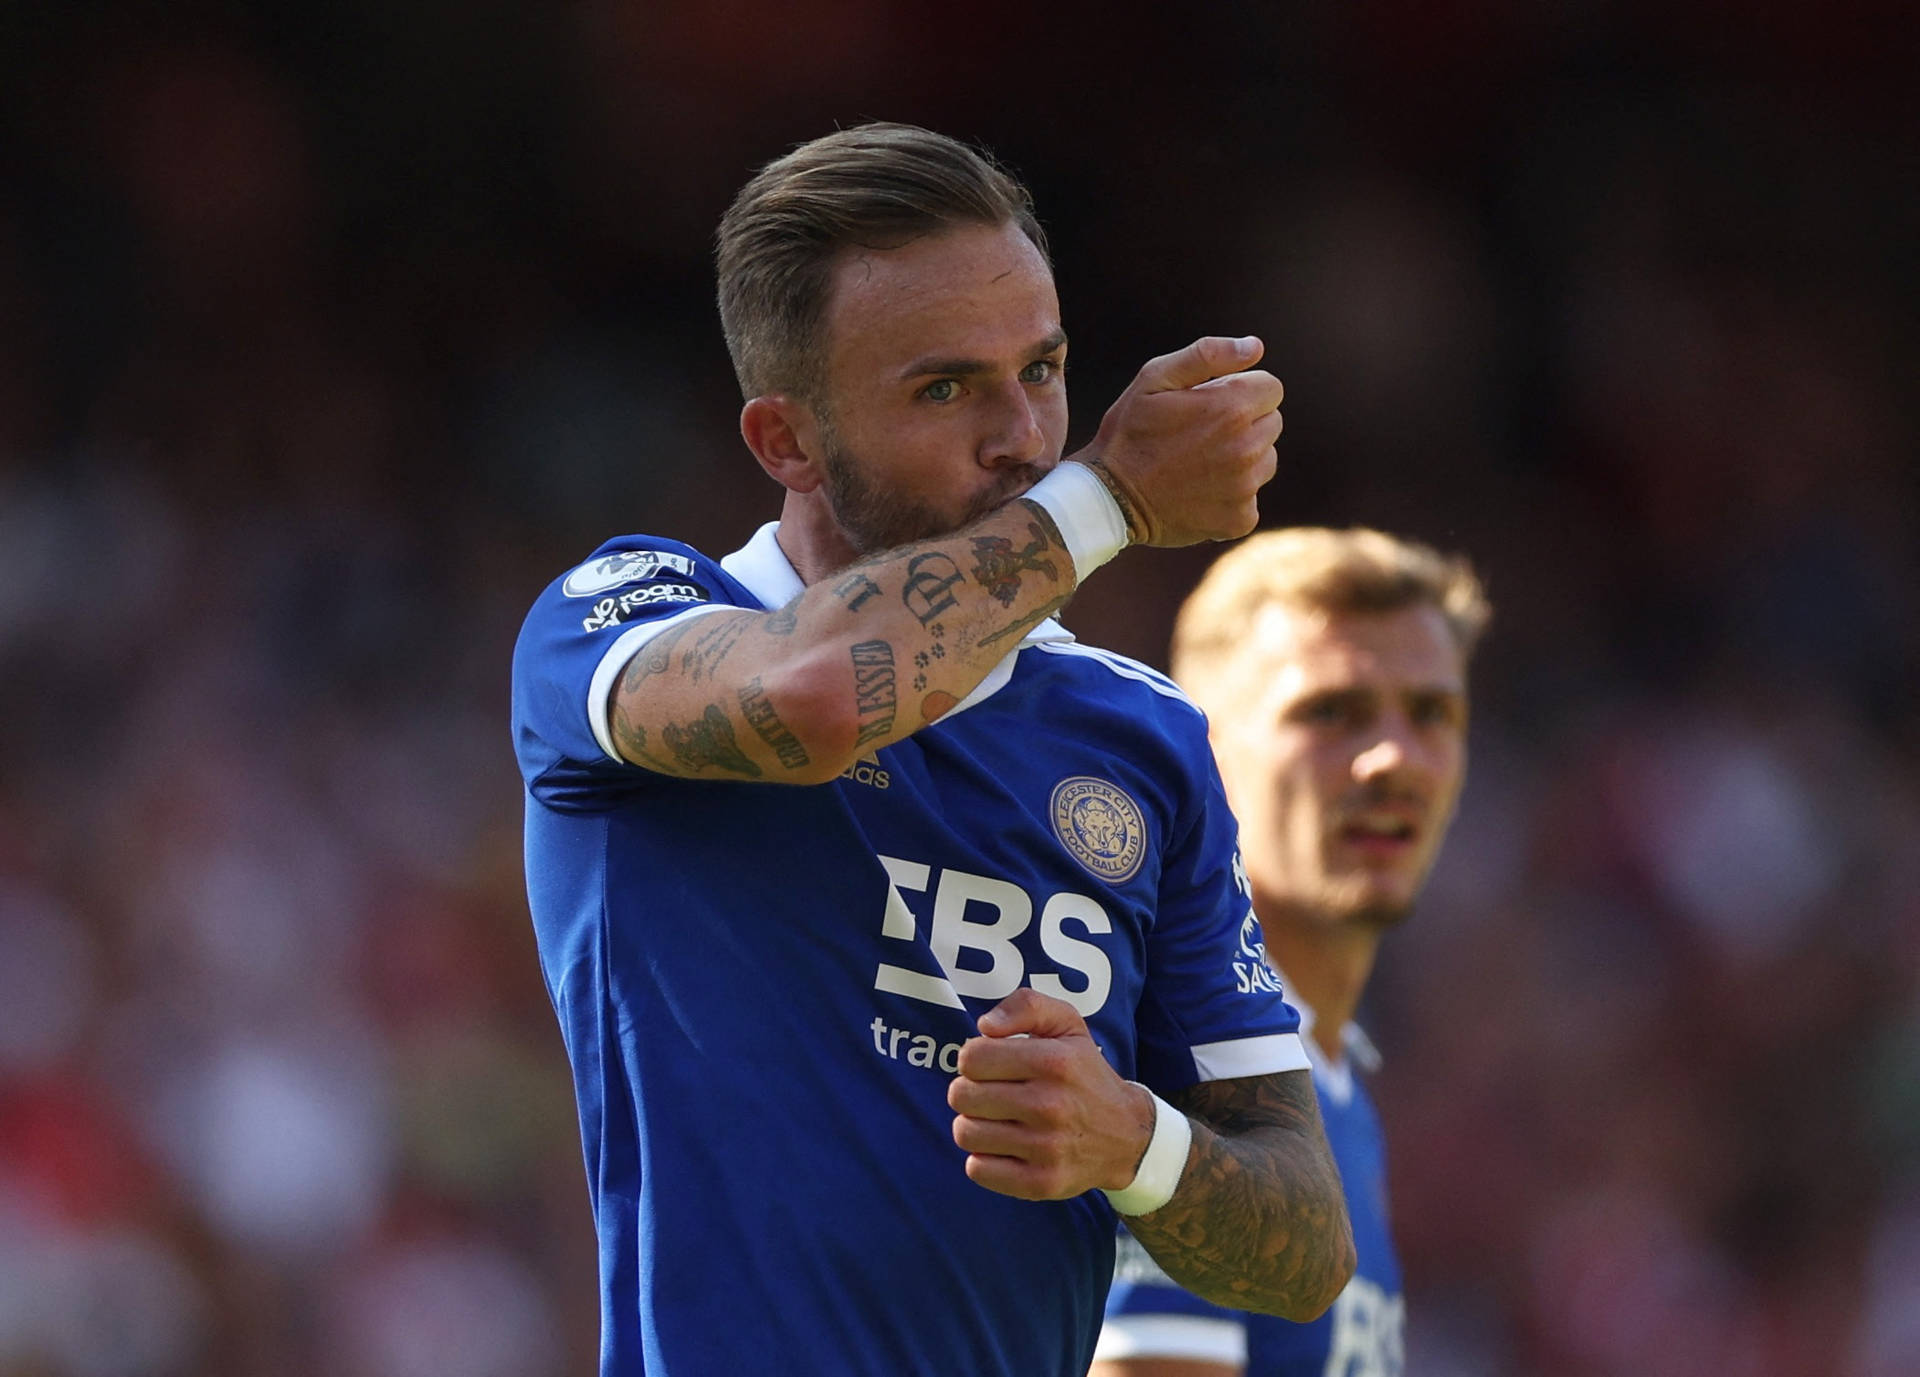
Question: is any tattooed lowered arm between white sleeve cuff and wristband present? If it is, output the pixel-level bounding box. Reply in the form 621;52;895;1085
1127;1072;1354;1319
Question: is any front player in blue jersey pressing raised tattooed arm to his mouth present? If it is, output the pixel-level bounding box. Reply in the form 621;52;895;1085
513;125;1352;1377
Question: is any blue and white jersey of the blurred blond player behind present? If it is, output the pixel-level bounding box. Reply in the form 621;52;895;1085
1098;1010;1405;1377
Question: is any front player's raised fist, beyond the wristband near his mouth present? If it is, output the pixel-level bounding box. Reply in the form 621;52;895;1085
1069;336;1286;545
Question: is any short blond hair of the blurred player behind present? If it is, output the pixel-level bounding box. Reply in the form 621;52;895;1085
1171;526;1492;689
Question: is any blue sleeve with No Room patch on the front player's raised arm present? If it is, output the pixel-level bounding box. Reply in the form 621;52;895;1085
513;536;741;793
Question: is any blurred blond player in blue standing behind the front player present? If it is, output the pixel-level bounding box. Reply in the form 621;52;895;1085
1092;528;1488;1377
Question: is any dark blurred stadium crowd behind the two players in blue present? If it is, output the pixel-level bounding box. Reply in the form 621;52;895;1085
0;0;1920;1377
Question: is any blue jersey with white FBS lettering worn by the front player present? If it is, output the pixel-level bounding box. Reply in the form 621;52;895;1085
513;526;1308;1377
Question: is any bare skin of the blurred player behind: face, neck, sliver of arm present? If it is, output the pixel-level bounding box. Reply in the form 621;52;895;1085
1089;605;1467;1377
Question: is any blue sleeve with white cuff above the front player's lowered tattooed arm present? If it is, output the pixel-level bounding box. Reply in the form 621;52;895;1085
1139;737;1309;1095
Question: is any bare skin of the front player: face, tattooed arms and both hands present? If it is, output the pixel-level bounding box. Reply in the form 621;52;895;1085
609;225;1354;1317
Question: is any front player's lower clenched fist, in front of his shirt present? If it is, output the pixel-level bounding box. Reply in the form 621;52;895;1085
947;987;1154;1200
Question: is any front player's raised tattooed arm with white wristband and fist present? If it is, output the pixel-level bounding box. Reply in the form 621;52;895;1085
607;336;1283;784
